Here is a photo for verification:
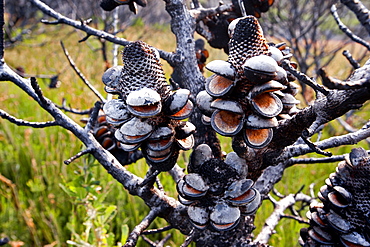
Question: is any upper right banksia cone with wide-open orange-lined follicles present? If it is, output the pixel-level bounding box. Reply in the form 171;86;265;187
197;16;299;152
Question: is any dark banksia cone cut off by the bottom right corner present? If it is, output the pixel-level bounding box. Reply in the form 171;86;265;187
300;148;370;247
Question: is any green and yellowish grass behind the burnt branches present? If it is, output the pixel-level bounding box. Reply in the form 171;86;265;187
0;21;367;246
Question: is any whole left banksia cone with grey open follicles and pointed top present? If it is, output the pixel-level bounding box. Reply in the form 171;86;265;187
99;41;195;171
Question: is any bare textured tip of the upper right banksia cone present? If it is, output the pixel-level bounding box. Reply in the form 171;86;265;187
228;16;269;74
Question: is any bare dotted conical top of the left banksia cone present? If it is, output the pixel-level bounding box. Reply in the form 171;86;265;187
121;40;169;99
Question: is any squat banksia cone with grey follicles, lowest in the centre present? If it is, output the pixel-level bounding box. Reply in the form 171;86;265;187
177;144;261;231
